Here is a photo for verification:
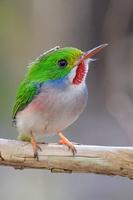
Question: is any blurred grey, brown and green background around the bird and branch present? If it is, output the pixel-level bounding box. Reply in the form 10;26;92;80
0;0;133;200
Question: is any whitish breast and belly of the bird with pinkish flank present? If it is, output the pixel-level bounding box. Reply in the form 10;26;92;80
16;80;88;134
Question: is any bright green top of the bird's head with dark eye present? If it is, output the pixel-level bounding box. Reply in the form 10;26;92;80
26;47;83;82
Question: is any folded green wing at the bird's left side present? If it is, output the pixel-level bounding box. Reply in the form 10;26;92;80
12;81;38;119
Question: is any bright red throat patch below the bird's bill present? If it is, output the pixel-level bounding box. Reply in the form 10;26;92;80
72;62;86;85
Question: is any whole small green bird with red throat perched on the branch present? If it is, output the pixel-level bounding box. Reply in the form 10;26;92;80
12;44;107;158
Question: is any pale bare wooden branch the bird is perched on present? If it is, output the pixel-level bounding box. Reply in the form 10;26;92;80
0;139;133;179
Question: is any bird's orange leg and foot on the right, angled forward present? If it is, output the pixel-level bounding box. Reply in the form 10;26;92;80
58;132;77;156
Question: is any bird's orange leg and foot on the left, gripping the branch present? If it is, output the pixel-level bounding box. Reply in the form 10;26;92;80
31;132;41;160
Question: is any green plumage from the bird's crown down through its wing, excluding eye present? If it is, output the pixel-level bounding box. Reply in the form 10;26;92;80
12;47;83;119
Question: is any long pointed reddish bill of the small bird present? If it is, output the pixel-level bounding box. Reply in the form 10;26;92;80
80;44;108;63
